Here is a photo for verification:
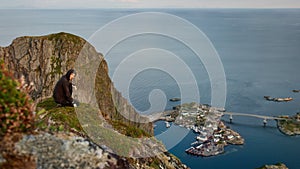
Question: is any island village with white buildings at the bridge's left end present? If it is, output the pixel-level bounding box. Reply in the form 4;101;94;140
159;102;244;157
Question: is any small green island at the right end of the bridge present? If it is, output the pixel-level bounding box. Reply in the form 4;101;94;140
277;112;300;136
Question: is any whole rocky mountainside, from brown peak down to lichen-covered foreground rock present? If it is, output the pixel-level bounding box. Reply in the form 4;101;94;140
0;33;187;169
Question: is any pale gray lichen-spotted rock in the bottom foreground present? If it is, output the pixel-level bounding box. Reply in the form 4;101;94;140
14;133;129;169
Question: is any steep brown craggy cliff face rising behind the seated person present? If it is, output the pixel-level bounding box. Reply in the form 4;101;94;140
0;33;153;134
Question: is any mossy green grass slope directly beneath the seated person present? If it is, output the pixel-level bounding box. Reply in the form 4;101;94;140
37;98;158;156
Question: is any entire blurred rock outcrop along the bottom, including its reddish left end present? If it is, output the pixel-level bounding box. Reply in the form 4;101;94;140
0;133;187;169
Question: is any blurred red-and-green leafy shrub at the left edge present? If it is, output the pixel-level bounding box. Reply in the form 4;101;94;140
0;61;34;136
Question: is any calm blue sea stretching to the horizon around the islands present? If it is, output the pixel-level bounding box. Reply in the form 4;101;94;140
0;9;300;169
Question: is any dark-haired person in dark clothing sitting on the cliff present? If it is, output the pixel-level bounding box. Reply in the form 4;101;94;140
53;69;77;107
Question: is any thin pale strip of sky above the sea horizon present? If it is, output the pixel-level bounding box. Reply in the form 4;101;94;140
0;0;300;9
